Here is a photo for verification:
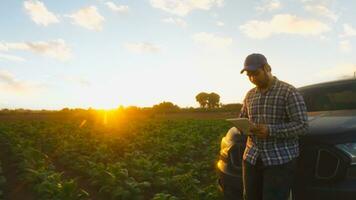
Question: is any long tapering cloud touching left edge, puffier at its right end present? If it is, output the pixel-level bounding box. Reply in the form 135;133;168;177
0;39;72;61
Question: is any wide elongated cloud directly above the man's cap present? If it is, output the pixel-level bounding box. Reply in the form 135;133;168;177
240;14;330;39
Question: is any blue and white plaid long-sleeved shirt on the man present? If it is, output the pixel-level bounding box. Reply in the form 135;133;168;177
240;77;308;166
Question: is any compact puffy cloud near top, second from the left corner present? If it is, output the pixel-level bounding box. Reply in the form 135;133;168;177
69;6;105;31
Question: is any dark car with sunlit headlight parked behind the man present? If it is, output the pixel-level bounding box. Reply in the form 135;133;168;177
217;79;356;200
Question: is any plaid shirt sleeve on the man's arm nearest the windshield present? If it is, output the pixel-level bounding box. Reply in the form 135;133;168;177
267;88;308;138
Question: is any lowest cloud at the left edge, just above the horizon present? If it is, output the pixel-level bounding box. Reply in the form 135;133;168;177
0;71;39;94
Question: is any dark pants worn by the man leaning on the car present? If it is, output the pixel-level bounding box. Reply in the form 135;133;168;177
242;159;296;200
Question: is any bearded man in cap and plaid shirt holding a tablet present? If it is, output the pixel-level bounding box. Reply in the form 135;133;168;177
240;54;308;200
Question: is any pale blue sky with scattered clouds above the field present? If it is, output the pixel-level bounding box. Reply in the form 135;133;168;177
0;0;356;110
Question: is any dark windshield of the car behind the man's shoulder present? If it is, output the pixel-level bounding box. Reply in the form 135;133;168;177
300;82;356;111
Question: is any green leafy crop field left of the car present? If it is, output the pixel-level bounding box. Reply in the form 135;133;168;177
0;115;231;200
